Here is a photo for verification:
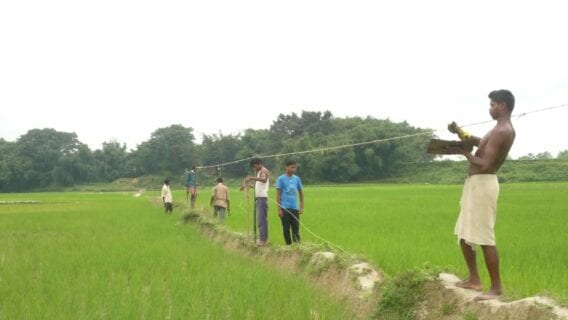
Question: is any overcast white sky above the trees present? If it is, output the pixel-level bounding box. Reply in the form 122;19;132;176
0;0;568;156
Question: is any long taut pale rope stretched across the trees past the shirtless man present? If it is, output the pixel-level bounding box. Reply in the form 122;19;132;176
197;103;568;169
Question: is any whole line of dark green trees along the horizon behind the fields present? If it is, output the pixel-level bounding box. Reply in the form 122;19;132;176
0;111;568;192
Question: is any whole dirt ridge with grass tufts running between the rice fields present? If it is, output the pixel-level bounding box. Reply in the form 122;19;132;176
182;211;568;320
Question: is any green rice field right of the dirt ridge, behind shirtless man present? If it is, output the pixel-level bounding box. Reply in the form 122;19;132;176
214;183;568;304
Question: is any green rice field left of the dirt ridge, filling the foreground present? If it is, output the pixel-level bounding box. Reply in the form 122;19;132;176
0;193;352;319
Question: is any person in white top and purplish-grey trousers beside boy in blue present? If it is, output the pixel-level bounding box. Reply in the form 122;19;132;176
241;158;270;246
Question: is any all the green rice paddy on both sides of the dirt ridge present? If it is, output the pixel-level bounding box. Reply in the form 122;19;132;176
0;183;568;319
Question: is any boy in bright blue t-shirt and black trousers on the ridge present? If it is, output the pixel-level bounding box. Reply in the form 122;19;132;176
276;160;304;245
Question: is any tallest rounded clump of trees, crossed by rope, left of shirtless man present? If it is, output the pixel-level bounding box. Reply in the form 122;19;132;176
262;112;432;182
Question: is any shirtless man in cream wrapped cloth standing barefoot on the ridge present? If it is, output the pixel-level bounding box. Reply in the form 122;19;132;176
448;90;515;301
